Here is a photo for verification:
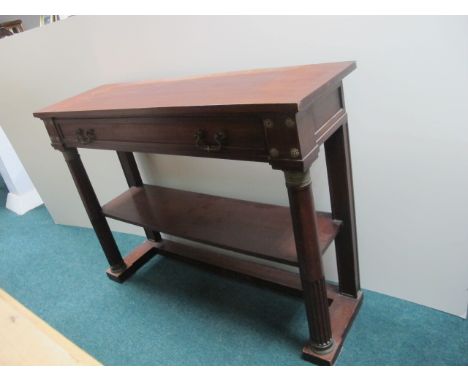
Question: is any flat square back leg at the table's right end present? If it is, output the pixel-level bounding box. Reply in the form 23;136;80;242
325;125;360;297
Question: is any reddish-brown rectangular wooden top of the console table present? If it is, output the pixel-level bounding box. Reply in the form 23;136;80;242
34;61;356;118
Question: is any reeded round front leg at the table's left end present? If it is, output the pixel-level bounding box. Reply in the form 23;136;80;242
63;149;127;272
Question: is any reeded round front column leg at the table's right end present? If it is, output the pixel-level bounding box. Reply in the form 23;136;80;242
285;170;333;354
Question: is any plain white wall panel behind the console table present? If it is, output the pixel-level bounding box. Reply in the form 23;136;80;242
0;16;468;316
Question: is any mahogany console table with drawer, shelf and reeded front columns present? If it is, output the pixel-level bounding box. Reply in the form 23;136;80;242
34;62;362;364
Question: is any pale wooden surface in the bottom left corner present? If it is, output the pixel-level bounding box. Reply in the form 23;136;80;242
0;289;100;366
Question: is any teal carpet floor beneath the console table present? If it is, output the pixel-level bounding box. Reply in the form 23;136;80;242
0;190;468;365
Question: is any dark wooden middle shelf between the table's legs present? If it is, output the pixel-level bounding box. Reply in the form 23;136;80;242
102;185;341;265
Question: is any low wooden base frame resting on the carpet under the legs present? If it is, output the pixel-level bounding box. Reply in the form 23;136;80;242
107;240;363;365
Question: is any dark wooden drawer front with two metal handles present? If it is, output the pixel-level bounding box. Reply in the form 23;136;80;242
56;116;266;159
